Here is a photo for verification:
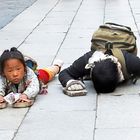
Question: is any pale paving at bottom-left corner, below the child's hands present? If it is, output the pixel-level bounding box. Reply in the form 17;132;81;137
0;106;28;140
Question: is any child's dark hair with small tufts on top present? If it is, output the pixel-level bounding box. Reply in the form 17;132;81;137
0;47;26;74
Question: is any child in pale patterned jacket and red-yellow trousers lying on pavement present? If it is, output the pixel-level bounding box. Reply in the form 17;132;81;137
0;47;62;109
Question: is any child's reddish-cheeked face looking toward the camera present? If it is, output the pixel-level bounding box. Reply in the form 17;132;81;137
4;58;25;84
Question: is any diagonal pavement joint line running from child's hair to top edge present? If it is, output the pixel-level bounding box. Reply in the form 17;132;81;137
17;0;61;48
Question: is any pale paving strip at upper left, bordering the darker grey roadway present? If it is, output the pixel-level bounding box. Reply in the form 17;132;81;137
0;0;57;49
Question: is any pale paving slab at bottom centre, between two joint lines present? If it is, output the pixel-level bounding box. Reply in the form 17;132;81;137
15;111;95;140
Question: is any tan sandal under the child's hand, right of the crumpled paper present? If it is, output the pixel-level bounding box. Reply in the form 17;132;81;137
12;99;34;108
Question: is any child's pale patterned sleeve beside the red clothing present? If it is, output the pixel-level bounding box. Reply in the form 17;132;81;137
23;67;40;99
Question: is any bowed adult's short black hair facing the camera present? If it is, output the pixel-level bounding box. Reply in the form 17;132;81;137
91;59;118;93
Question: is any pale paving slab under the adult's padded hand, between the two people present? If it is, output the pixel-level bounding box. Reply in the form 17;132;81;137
29;82;97;111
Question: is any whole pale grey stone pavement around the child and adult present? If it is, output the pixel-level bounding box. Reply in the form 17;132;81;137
0;0;140;140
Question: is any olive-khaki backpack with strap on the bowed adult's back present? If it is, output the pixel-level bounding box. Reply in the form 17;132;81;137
91;22;137;82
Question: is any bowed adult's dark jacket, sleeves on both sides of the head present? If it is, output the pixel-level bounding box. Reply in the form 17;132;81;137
59;51;140;87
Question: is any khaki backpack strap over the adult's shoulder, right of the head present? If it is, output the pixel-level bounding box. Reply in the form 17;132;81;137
111;48;130;79
